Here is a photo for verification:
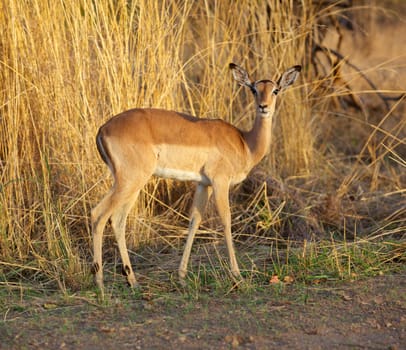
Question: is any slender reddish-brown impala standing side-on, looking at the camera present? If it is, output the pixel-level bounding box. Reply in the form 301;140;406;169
91;63;301;290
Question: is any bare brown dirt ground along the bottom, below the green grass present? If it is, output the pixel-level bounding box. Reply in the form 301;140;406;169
0;274;406;350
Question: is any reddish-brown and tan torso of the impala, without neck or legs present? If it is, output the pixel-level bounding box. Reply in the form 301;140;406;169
97;109;252;185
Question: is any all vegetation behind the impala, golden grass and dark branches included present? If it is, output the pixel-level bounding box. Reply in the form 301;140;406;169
0;0;406;291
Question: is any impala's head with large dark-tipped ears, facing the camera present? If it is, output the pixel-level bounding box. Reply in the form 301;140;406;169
230;63;302;118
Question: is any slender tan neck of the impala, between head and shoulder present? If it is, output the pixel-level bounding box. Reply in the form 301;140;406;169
244;99;276;166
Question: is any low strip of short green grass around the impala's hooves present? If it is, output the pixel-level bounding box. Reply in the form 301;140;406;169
0;232;406;312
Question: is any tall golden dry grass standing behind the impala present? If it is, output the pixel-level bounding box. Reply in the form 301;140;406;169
0;0;405;289
